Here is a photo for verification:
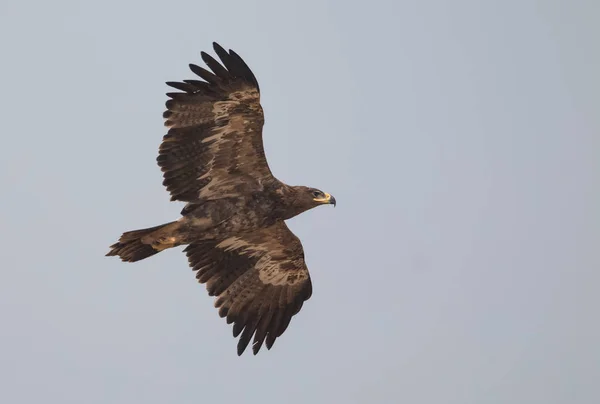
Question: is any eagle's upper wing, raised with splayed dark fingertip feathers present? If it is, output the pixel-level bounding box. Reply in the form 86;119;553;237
157;43;273;202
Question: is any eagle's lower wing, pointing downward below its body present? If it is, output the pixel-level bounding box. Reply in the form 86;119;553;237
184;222;312;355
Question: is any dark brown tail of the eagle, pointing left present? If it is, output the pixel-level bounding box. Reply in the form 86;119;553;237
106;222;179;262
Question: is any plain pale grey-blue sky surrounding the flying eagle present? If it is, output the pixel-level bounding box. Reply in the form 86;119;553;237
0;0;600;404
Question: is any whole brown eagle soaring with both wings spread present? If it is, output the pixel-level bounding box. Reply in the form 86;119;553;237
106;42;336;355
